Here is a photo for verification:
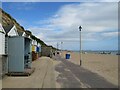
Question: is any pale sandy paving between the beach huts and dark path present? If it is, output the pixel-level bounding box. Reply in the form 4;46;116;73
2;57;56;88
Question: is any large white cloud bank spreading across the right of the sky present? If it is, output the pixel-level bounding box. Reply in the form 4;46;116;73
26;3;118;49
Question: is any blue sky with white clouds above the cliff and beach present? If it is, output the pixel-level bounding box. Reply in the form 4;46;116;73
2;0;118;50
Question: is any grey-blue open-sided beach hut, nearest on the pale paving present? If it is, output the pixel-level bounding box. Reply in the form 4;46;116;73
8;36;32;73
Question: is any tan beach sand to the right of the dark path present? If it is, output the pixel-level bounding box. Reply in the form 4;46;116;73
61;51;118;85
